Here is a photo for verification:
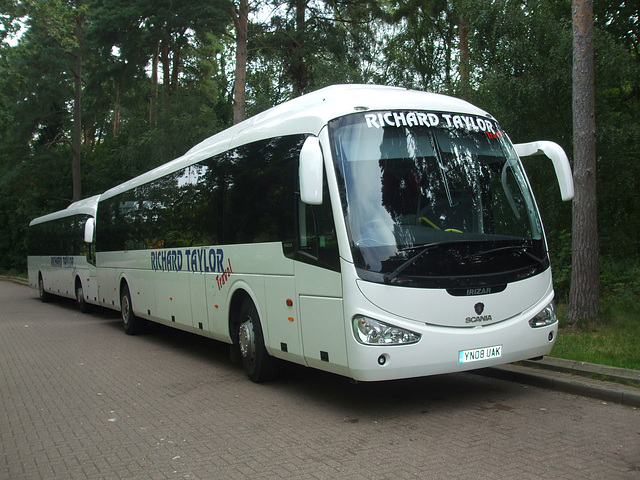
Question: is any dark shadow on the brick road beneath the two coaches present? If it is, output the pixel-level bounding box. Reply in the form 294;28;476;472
40;298;524;414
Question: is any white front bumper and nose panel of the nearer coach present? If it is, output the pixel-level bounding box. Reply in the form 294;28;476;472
343;268;558;381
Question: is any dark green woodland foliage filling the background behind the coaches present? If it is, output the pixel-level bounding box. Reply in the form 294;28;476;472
0;0;640;320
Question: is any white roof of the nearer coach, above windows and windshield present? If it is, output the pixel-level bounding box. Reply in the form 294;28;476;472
101;85;488;199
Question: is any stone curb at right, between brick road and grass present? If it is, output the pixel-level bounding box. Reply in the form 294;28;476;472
477;357;640;408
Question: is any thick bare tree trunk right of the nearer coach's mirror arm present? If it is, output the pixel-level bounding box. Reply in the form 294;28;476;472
567;0;600;324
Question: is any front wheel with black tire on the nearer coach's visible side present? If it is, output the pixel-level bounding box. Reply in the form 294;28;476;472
238;298;278;383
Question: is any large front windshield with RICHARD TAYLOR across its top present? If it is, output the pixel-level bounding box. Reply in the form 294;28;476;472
329;111;549;289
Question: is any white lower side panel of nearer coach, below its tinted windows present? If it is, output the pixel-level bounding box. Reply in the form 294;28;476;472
98;243;349;375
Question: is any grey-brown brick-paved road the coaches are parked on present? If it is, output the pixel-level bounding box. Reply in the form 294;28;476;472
0;281;640;480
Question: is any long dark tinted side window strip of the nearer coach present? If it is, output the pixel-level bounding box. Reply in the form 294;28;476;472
96;135;305;251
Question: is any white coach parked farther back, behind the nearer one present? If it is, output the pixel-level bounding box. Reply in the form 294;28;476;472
27;196;98;312
